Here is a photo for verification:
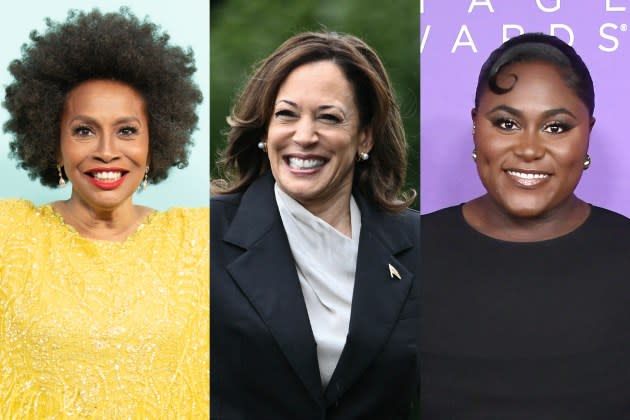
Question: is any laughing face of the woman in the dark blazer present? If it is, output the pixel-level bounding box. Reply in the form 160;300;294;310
266;61;372;208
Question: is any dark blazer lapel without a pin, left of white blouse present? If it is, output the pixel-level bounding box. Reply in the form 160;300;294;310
224;175;323;404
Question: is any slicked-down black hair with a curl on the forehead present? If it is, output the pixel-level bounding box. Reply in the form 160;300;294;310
475;32;595;116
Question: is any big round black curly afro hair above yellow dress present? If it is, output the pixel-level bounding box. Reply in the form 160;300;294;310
3;8;202;187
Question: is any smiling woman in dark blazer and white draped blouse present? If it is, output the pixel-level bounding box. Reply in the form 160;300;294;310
211;32;419;420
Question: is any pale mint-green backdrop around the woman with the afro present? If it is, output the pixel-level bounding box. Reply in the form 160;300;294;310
0;0;210;210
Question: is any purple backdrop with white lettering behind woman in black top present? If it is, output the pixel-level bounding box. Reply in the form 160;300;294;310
420;0;630;216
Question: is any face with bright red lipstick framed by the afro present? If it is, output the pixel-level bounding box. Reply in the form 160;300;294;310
60;80;149;210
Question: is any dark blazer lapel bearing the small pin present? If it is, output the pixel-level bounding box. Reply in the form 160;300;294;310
325;194;414;404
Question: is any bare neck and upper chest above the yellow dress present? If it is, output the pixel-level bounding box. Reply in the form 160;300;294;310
53;194;150;241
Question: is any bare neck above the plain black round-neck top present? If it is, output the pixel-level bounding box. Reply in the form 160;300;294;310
463;194;590;242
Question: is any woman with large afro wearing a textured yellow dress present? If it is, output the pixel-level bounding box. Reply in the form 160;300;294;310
0;8;209;419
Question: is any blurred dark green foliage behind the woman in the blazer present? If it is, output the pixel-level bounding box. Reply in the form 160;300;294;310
210;0;420;209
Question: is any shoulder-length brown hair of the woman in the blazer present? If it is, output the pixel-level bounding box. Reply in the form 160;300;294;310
213;32;415;211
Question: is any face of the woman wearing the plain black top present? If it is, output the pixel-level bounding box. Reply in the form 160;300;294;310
472;62;594;217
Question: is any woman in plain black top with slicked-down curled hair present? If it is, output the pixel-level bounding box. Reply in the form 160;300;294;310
420;34;630;420
